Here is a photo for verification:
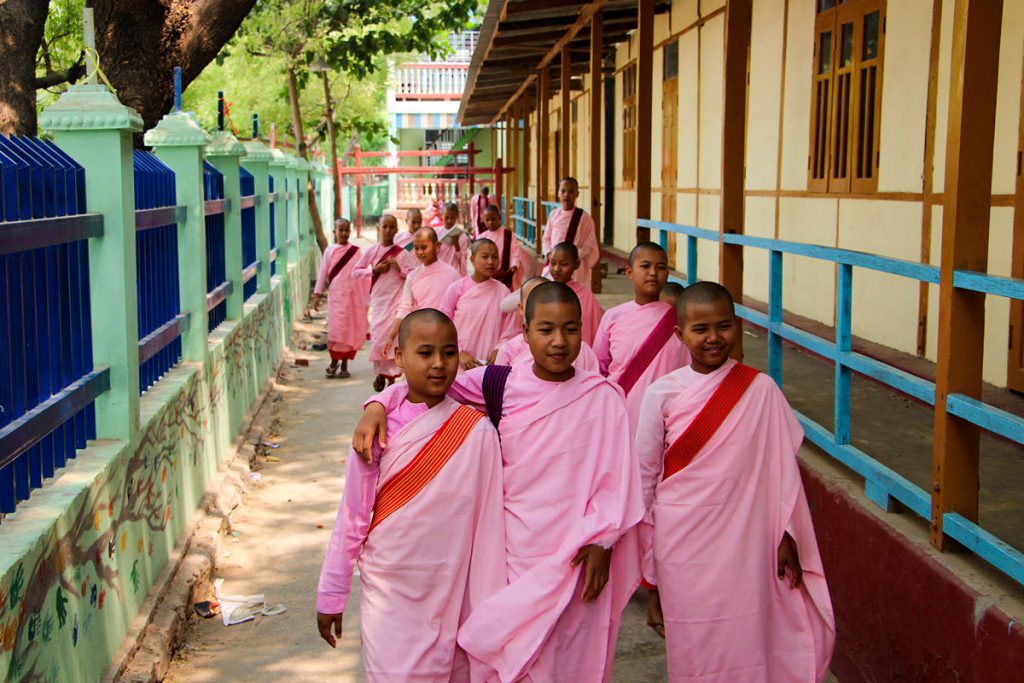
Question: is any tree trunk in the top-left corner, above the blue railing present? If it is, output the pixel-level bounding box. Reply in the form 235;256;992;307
0;0;49;135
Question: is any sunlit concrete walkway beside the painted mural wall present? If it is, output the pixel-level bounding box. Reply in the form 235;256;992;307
165;311;666;683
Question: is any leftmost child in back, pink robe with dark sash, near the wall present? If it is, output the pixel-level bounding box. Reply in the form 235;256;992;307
313;218;370;378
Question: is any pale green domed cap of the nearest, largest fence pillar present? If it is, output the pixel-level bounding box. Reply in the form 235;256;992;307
39;84;142;133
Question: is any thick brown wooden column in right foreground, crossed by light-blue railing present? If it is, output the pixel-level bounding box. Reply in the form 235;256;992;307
931;0;1002;550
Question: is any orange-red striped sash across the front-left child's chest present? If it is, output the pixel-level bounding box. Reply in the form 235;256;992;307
368;405;483;532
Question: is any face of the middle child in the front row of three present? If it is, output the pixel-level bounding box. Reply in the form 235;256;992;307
522;301;583;382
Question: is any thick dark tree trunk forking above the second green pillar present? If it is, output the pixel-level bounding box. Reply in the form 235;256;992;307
94;0;256;130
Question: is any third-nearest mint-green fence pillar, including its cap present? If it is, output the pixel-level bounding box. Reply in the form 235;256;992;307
206;130;246;321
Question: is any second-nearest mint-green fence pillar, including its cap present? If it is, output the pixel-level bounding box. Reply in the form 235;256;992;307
144;113;210;362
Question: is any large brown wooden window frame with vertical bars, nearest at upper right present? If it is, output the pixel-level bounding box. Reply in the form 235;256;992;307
807;0;886;194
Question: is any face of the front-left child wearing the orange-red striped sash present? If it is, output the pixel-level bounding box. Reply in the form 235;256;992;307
395;319;459;408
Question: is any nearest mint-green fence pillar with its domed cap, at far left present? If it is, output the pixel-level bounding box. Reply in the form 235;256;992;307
39;85;142;441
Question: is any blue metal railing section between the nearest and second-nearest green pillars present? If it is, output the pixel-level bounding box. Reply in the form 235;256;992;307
133;150;188;393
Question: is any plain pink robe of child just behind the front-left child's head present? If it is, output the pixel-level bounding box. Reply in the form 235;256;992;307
441;278;516;360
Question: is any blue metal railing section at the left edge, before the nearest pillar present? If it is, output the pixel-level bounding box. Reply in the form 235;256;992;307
0;135;102;513
